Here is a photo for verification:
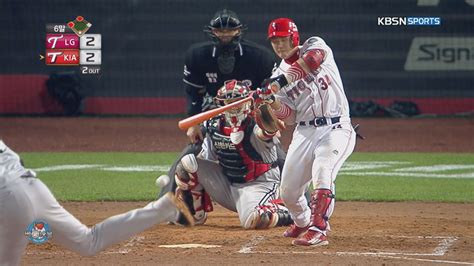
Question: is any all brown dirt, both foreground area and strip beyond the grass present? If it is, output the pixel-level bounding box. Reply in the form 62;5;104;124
0;118;474;265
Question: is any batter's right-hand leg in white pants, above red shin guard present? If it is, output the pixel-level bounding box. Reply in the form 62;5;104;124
312;123;356;218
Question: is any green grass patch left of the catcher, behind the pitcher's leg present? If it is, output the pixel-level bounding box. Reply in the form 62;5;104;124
21;153;177;201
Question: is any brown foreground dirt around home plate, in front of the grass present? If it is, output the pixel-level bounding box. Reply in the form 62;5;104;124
23;202;474;265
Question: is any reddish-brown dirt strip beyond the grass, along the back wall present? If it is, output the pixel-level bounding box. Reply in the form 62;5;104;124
0;117;474;152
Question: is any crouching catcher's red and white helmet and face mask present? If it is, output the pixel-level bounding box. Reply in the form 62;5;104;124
215;79;252;127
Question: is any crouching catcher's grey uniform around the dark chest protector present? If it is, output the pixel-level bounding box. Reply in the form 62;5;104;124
197;120;280;226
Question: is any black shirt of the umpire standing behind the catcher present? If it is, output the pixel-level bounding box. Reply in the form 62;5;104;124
183;40;276;116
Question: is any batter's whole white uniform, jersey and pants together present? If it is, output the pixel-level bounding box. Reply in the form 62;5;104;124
273;37;356;231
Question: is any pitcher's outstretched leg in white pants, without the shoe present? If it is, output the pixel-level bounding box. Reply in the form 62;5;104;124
30;179;179;256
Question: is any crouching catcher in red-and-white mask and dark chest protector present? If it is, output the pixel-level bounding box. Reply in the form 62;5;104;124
175;80;293;229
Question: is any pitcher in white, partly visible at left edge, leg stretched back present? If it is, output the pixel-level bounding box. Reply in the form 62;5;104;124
0;140;193;265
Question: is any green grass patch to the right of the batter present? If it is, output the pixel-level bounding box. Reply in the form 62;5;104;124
336;153;474;202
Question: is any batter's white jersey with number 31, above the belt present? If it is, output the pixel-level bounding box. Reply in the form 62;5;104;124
272;37;349;122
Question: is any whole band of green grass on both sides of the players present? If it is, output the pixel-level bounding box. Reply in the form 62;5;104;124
21;153;474;203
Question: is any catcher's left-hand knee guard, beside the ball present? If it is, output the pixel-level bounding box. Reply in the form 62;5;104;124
174;154;199;190
